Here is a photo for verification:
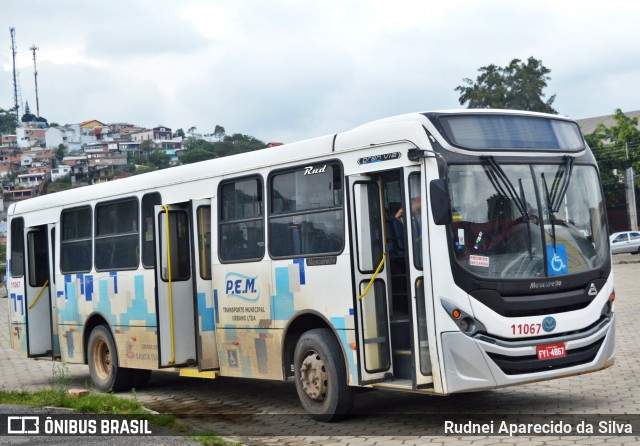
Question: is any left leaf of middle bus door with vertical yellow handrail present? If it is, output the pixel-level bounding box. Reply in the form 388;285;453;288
155;204;196;367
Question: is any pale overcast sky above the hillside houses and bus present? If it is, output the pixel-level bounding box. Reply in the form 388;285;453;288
0;0;640;142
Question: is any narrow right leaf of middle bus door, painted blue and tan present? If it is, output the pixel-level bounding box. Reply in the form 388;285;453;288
191;199;220;371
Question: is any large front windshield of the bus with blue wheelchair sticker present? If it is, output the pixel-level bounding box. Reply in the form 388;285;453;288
449;160;609;279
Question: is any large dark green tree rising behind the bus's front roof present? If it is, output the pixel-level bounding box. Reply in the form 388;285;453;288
455;57;557;114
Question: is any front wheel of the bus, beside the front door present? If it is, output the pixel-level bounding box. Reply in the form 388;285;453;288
294;328;354;421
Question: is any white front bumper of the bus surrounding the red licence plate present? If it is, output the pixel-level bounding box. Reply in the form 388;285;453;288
442;313;615;393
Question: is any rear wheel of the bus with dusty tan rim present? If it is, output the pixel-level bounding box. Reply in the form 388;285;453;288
88;325;131;392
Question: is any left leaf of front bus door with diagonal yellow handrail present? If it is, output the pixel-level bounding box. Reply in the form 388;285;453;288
348;175;393;384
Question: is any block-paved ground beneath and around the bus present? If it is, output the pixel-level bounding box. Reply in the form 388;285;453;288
0;255;640;445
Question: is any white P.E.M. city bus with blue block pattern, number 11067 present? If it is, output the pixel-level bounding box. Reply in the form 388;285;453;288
8;110;615;420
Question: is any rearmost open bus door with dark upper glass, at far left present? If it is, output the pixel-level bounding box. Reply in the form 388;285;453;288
25;225;53;357
